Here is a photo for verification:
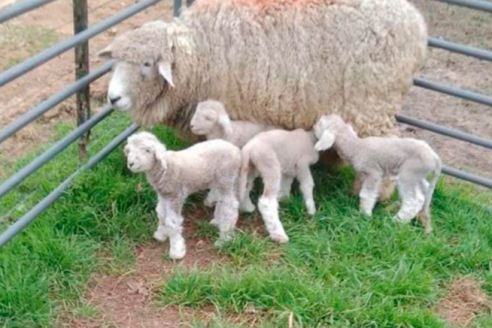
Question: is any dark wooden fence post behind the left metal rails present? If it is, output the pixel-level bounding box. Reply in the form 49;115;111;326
73;0;91;161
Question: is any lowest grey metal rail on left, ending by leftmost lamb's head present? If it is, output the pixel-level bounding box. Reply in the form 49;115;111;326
0;124;138;248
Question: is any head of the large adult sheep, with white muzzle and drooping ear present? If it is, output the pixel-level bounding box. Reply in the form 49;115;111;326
98;21;174;111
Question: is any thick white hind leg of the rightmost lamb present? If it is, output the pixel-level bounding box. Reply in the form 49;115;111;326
394;177;425;223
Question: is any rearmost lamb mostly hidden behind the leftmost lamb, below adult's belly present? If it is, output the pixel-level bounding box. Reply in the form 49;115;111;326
190;100;278;212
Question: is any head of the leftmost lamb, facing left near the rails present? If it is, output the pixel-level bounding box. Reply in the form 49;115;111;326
124;132;166;173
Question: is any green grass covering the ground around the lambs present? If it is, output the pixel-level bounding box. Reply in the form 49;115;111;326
0;115;492;328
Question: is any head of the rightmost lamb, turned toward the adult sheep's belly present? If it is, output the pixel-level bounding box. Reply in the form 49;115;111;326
313;114;357;151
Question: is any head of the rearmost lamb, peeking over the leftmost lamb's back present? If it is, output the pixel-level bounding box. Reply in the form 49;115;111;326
190;100;232;135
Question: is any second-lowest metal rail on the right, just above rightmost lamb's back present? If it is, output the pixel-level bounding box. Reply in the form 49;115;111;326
396;114;492;149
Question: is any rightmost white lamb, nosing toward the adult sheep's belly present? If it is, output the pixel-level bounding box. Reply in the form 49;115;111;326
314;114;442;234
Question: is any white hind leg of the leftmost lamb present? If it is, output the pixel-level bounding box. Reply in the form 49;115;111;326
214;190;239;246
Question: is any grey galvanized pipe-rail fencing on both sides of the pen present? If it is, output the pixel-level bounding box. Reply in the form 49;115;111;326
0;0;492;248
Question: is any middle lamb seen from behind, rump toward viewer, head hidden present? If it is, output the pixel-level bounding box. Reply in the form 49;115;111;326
239;129;319;243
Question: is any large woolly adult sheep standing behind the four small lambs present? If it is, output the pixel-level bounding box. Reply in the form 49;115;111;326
100;0;427;136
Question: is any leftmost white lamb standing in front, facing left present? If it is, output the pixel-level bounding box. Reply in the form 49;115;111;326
124;132;241;259
